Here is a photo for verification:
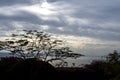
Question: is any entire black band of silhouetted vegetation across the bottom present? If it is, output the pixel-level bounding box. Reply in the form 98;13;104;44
0;51;120;80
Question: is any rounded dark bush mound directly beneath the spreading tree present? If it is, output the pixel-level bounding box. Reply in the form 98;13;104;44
11;58;55;80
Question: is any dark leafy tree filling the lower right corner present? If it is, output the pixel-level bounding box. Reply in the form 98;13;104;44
85;50;120;80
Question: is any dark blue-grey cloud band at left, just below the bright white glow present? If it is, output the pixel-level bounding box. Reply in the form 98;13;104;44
0;12;42;24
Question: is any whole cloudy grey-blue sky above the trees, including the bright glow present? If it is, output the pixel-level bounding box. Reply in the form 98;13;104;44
0;0;120;56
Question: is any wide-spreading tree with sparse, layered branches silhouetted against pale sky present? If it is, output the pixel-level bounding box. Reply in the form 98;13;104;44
0;30;83;61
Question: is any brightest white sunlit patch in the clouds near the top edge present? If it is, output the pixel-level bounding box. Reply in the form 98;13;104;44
20;0;56;17
